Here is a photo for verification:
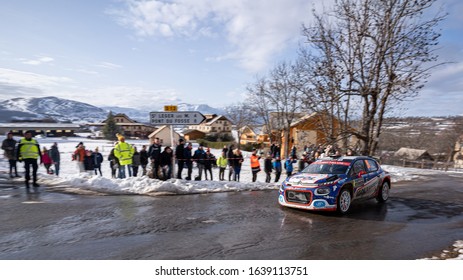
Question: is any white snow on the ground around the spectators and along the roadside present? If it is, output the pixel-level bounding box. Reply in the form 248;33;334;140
0;136;463;259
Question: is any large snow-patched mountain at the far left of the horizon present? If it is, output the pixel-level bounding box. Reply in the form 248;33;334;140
0;96;107;123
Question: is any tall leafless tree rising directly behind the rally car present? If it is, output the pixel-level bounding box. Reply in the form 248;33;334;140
303;0;445;155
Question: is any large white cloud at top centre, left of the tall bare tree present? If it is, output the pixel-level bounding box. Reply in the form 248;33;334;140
109;0;326;72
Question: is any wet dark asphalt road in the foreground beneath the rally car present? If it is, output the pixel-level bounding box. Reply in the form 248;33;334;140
0;175;463;260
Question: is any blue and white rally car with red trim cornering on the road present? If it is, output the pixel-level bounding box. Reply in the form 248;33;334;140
278;156;391;214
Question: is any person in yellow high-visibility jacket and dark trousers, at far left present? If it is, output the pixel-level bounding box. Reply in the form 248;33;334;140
16;130;42;188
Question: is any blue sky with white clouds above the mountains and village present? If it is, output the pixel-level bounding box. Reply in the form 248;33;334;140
0;0;463;116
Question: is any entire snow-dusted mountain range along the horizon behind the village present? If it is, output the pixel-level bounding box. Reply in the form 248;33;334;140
0;96;225;123
